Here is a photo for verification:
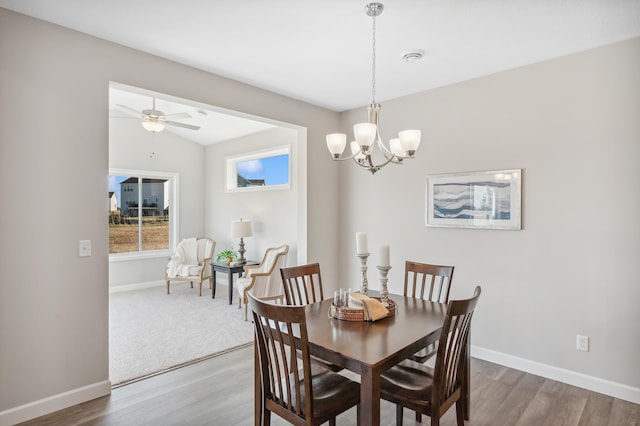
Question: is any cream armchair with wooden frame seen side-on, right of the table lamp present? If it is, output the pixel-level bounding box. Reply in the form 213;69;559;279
238;245;289;321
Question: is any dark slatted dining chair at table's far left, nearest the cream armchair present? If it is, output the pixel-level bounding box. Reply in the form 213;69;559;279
280;263;324;305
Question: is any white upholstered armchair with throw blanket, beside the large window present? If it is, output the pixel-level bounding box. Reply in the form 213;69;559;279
165;237;216;296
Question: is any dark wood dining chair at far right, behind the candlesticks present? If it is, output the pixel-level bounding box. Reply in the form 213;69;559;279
404;261;454;362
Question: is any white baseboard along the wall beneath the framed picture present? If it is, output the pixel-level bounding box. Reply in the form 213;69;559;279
471;345;640;404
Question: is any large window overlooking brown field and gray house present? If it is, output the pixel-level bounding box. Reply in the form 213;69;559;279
109;170;177;257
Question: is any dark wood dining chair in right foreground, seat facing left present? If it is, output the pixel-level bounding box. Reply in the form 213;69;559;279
380;286;481;426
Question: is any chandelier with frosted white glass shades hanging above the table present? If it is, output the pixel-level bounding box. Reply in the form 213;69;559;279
327;3;421;174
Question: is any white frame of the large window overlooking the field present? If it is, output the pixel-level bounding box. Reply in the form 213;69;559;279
109;168;180;262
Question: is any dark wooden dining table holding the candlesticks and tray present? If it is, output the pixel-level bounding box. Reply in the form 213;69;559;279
256;294;469;426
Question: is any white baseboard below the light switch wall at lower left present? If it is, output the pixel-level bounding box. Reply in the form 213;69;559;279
0;380;111;426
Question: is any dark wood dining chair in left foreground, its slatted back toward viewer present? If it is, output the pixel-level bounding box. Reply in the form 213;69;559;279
248;293;360;426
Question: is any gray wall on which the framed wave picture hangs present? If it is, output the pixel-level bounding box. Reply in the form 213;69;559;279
340;39;640;396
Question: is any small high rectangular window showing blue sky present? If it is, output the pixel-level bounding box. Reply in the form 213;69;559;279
226;145;290;191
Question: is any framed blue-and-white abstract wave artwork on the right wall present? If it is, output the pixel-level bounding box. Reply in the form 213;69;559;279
425;169;522;230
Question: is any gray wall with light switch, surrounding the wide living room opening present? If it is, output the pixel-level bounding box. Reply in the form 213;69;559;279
0;9;339;424
